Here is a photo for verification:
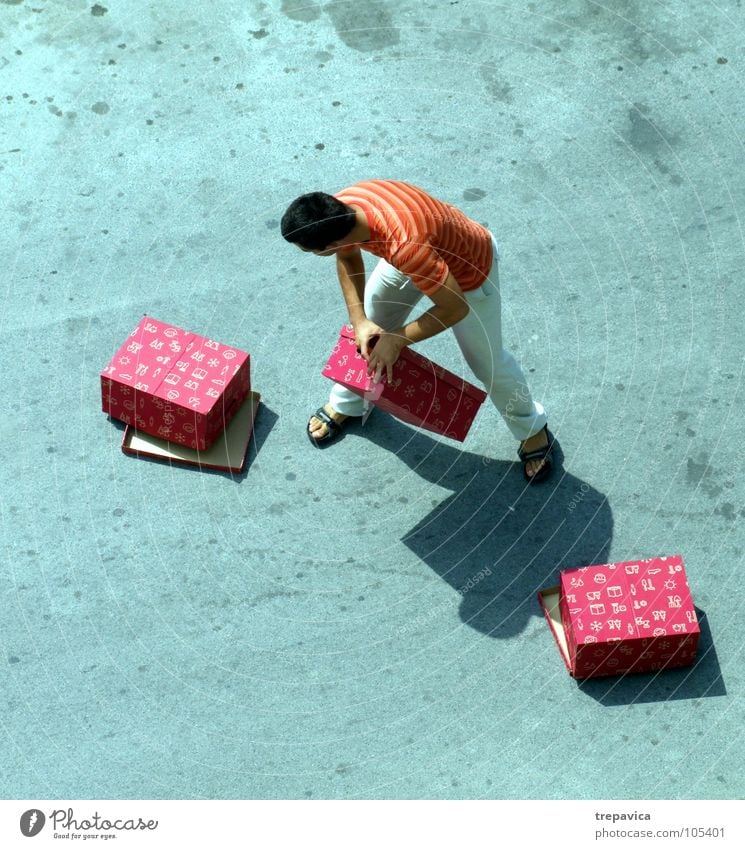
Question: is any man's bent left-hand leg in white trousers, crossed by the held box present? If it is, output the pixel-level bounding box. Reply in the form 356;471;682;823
308;259;422;439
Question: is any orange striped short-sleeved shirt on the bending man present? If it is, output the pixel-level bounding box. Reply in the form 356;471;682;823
335;180;492;295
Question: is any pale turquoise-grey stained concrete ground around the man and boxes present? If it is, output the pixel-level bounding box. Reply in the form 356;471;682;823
0;0;745;799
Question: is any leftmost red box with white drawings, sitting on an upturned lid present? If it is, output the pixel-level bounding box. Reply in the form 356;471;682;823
101;316;251;451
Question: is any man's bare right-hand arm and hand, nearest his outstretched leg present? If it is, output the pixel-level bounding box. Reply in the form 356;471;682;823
367;274;469;381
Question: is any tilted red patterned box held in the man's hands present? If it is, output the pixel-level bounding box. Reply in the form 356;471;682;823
322;324;486;442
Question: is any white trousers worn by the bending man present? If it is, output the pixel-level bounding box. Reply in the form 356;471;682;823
329;236;547;440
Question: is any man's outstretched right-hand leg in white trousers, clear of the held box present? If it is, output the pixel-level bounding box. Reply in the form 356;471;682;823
453;238;548;474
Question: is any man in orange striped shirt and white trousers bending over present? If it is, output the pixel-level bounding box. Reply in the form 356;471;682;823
282;180;552;482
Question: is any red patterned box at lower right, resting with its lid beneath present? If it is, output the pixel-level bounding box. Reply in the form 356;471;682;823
539;555;700;678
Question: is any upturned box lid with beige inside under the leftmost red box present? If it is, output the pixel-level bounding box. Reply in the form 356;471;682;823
122;392;261;472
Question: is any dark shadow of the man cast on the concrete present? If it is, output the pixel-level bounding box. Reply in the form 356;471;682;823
358;417;613;638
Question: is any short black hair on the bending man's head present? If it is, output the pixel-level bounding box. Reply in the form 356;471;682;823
281;192;356;251
